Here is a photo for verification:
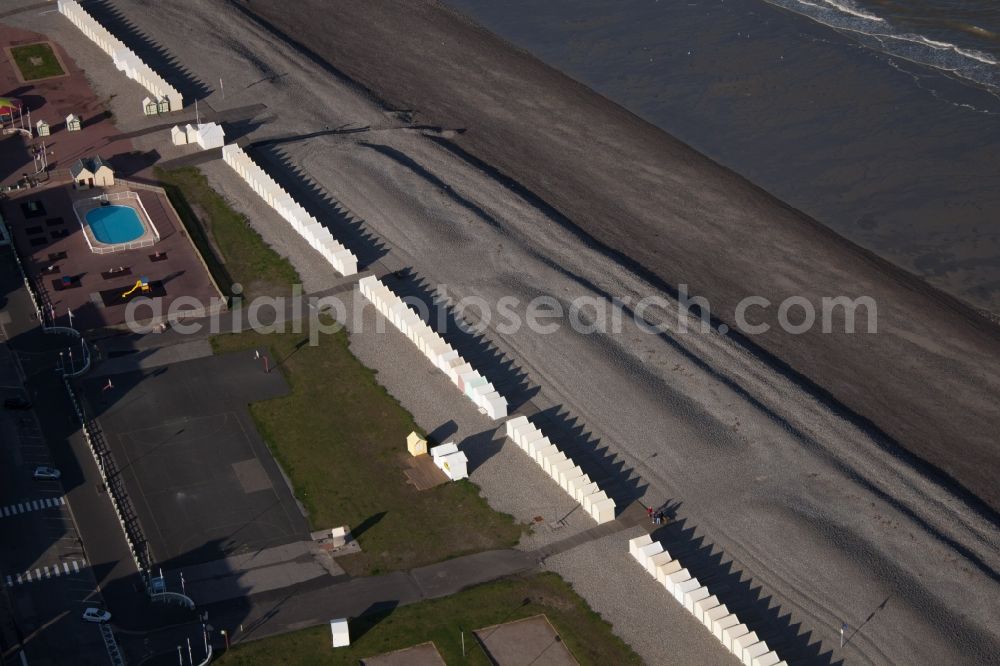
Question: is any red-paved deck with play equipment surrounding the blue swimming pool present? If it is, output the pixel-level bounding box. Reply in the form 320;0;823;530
0;178;220;330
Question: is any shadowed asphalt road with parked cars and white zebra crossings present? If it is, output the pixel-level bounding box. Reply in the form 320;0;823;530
0;251;201;666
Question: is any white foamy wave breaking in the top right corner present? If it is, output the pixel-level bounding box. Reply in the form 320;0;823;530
764;0;1000;92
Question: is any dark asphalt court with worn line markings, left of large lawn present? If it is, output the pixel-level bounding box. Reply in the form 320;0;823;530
85;351;309;567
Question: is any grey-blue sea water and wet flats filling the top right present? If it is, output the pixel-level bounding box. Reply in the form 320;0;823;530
447;0;1000;313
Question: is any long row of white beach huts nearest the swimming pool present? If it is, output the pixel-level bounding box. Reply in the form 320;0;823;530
222;143;358;276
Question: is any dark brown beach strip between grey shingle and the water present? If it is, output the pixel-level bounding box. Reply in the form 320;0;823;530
238;1;1000;522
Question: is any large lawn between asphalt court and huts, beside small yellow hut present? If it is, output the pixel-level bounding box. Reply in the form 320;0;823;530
212;330;523;574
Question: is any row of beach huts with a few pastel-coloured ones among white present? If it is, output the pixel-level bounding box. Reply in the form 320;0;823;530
358;275;507;420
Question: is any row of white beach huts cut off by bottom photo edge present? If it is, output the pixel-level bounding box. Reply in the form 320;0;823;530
628;534;787;666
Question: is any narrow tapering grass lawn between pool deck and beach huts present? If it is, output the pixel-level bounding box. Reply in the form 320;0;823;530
156;167;299;298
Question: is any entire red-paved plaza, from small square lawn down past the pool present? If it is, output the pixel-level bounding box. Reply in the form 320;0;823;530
0;24;219;330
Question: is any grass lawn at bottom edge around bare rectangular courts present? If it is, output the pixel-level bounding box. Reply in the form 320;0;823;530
218;573;642;666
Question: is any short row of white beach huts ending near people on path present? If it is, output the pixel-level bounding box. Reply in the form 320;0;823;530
506;416;615;524
